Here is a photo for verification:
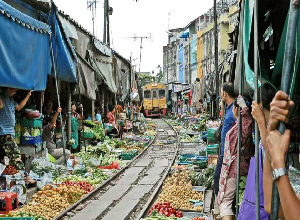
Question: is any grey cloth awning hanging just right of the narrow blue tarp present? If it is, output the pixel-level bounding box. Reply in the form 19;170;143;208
75;55;96;101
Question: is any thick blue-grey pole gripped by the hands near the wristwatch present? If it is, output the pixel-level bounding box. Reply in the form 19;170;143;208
270;0;299;220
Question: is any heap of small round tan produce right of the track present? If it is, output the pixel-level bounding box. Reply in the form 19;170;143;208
158;170;204;212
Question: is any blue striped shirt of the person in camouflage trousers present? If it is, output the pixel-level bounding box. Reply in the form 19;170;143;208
0;95;18;135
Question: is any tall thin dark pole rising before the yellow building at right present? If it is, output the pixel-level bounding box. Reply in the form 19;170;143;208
214;0;219;118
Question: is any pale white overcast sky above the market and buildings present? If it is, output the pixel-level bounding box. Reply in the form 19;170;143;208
54;0;213;72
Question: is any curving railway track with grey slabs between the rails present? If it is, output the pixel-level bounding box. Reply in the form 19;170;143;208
56;119;178;220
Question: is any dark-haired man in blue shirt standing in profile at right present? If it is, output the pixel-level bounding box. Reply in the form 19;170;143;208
214;82;235;195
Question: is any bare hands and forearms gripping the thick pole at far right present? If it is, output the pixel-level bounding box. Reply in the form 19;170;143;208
263;91;300;219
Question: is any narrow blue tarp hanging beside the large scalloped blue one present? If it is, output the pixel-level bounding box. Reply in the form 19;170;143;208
49;4;77;83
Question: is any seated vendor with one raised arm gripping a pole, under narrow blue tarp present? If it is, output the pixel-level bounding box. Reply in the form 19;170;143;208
43;107;71;165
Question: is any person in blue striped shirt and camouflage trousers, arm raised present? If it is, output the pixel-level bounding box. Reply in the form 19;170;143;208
0;88;35;183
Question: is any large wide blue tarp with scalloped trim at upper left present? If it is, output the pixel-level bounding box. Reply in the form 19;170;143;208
0;1;51;91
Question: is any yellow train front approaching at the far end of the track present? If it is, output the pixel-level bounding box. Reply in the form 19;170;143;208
143;83;167;117
